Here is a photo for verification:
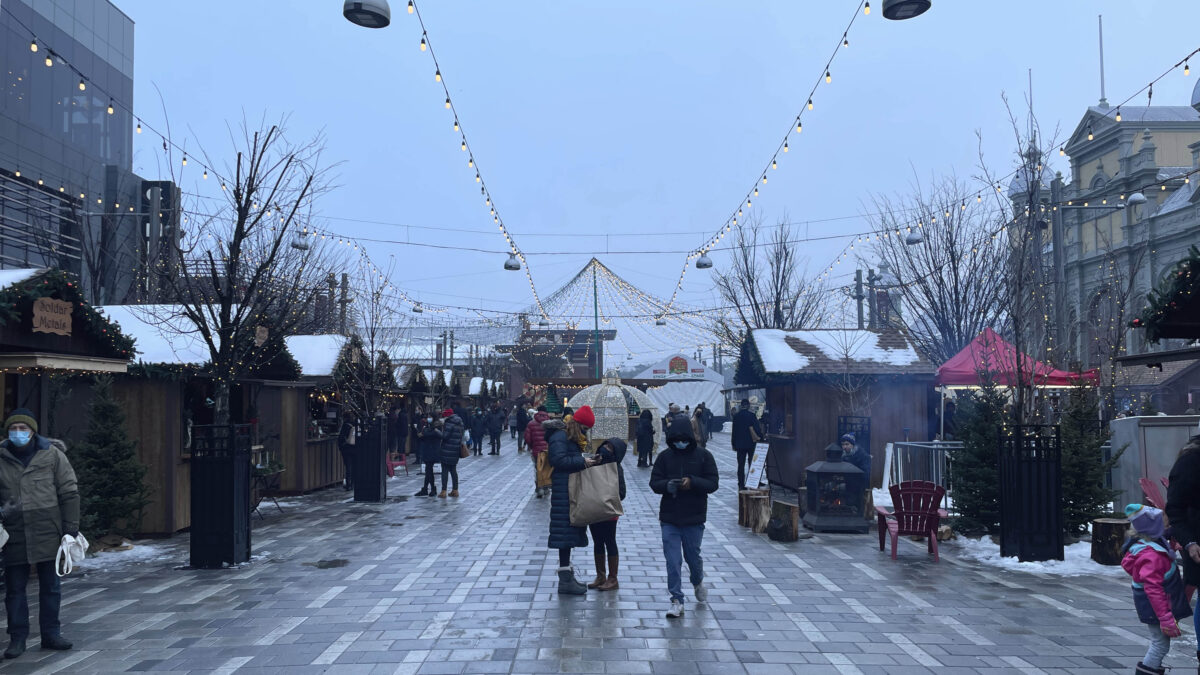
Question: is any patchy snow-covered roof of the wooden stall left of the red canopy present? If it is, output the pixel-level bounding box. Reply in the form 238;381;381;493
750;328;935;375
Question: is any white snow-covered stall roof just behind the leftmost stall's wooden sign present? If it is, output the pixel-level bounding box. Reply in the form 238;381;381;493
96;305;209;365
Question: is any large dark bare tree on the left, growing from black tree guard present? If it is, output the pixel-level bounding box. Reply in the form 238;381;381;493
149;116;336;424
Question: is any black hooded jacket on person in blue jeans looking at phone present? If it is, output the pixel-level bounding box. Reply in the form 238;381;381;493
650;417;720;526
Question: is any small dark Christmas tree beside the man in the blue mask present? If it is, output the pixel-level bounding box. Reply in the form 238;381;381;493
68;376;150;539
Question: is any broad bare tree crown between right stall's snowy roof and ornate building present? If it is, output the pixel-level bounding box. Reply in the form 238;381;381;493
874;172;1008;364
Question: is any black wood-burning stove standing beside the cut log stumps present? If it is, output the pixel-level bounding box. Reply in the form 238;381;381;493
804;443;870;533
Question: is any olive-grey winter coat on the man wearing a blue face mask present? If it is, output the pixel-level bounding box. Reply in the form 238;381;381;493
0;435;81;565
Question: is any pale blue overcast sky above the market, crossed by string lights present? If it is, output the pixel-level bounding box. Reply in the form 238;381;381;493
114;0;1200;357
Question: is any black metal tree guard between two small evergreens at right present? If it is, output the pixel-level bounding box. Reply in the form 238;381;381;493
998;424;1063;562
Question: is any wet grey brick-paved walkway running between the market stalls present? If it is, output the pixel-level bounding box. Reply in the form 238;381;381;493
0;435;1195;674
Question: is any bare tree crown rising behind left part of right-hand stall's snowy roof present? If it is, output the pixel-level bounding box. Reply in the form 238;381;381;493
713;217;828;348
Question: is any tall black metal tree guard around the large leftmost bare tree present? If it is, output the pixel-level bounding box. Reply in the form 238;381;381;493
191;424;251;568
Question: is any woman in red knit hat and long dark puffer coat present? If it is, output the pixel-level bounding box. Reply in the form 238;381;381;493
541;406;596;596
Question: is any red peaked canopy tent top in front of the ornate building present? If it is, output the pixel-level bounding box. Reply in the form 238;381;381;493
934;328;1099;387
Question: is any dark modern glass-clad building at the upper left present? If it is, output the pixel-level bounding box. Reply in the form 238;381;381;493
0;0;178;303
